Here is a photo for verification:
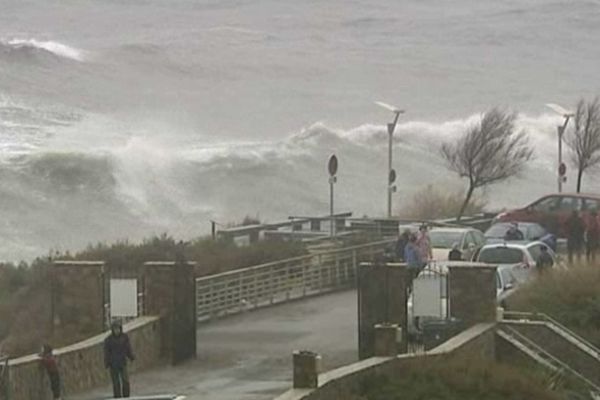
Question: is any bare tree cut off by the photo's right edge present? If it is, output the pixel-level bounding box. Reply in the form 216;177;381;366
565;97;600;193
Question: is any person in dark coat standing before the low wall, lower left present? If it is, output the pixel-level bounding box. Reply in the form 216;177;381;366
104;322;135;398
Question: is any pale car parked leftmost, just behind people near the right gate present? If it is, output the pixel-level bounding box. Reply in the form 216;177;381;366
429;228;485;261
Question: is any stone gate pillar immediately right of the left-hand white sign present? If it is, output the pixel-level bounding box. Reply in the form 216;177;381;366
144;262;196;364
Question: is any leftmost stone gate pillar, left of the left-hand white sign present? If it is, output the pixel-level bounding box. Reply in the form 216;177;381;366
51;261;108;335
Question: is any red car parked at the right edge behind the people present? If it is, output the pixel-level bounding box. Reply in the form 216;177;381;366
494;193;600;237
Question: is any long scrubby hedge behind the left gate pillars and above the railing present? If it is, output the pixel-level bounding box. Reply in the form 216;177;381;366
0;230;306;357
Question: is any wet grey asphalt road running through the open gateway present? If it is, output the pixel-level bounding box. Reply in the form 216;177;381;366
75;291;358;400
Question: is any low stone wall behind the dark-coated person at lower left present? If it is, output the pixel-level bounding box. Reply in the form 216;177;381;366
9;317;161;400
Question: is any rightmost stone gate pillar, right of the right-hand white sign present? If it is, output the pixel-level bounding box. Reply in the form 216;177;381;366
448;263;497;327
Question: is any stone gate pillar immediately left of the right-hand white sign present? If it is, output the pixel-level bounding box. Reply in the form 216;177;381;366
358;263;409;360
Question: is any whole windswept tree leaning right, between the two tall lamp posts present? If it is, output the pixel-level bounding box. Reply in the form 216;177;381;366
441;108;533;220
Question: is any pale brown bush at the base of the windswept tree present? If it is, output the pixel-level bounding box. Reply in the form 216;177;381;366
398;185;487;220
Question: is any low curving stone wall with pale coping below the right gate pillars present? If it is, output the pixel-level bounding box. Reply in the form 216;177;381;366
276;323;495;400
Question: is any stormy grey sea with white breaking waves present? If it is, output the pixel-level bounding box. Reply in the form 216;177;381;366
0;0;600;260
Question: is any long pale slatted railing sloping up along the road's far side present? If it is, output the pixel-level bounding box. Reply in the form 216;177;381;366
196;240;393;322
